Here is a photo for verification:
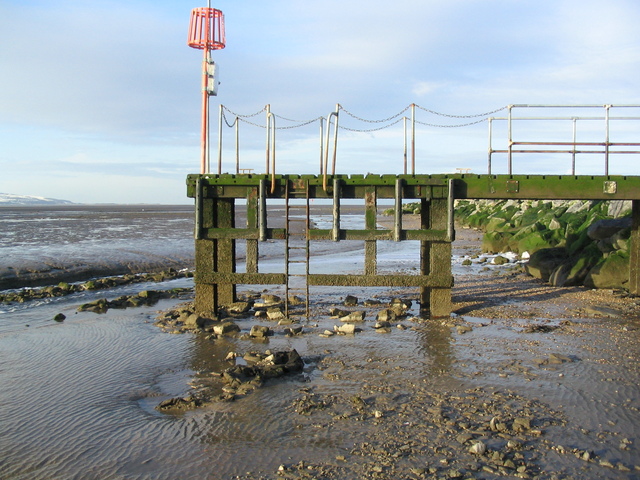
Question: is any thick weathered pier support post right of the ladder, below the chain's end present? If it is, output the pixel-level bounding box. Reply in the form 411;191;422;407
420;198;453;318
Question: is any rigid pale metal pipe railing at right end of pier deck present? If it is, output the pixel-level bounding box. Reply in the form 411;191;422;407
488;104;640;176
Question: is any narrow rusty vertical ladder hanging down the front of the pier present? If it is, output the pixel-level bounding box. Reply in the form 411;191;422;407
284;180;310;318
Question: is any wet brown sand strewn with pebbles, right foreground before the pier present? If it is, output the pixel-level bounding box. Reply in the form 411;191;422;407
152;223;640;480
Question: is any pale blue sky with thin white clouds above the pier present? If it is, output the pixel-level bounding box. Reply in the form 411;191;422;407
0;0;640;204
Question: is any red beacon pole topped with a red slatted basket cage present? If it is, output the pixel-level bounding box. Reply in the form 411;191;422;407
187;7;226;173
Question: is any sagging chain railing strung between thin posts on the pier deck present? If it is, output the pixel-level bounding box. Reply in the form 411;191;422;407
218;103;508;177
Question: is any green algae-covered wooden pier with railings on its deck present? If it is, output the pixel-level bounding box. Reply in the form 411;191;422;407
187;105;640;317
